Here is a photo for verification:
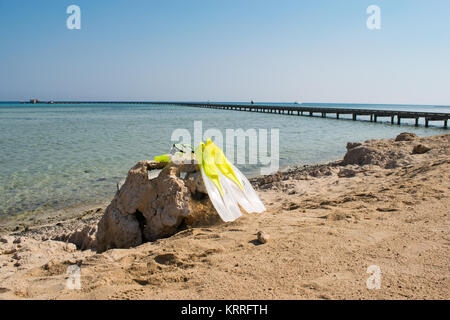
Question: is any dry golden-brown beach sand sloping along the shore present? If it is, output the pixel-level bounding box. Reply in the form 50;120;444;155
0;134;450;299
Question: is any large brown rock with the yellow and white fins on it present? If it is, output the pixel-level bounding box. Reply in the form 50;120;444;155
96;161;217;252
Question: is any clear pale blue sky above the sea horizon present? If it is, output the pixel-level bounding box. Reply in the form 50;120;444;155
0;0;450;105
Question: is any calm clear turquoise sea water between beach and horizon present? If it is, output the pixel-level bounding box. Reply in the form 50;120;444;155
0;103;450;216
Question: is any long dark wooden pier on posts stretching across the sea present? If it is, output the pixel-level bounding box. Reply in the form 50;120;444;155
26;101;450;129
